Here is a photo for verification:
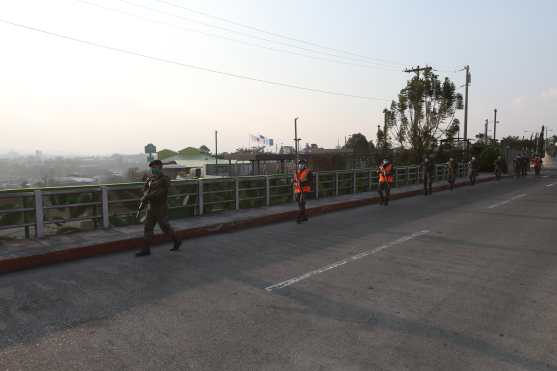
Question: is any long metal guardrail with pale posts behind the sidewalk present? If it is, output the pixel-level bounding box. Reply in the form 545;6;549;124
0;163;467;238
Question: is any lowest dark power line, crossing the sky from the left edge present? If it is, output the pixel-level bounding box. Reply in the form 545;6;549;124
0;18;390;101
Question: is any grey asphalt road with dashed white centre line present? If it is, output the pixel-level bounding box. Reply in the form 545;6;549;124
0;172;557;370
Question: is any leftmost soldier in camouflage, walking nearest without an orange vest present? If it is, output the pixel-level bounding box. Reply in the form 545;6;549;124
135;160;182;257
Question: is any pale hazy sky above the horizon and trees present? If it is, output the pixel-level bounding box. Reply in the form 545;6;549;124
0;0;557;154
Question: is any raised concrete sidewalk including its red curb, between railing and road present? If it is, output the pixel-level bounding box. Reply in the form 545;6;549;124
0;174;495;274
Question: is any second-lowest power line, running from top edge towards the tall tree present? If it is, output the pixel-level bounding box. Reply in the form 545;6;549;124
76;0;400;72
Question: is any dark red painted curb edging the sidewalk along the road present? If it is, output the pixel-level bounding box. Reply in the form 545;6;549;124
0;176;495;274
